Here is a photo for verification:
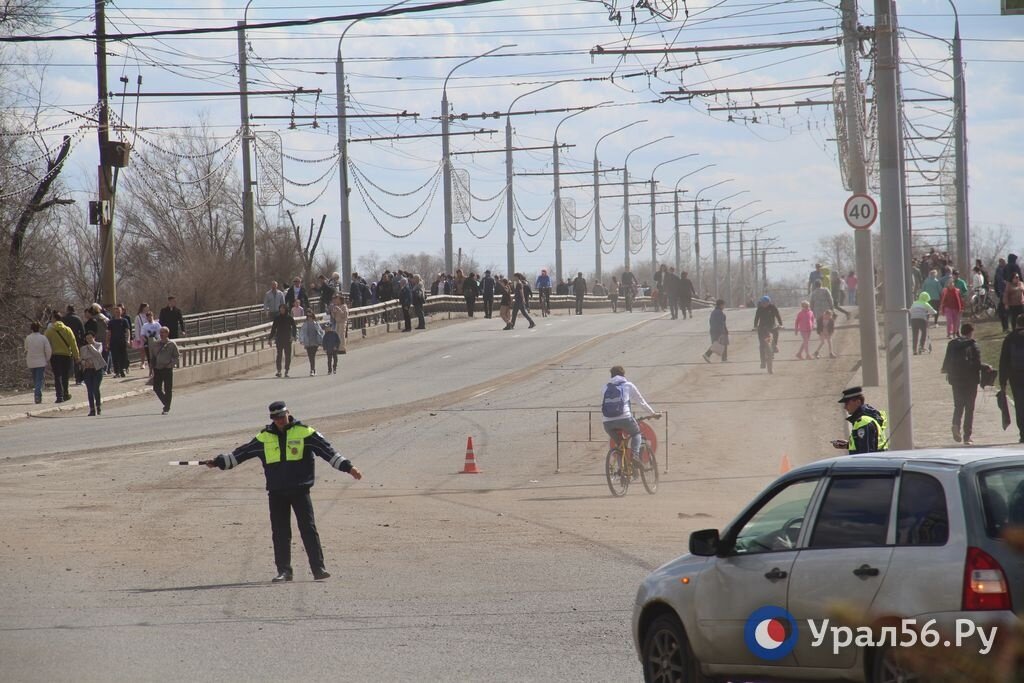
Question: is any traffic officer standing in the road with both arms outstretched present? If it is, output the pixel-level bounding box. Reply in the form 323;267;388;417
206;400;362;584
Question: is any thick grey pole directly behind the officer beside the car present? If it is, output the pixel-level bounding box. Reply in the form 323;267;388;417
872;0;913;451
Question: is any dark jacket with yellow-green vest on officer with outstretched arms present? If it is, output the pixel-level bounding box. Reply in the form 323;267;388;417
213;418;352;493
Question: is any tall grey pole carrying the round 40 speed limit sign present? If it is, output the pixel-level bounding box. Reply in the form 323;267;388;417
842;0;879;386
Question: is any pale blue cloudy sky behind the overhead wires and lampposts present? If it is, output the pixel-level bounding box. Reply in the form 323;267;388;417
10;0;1024;282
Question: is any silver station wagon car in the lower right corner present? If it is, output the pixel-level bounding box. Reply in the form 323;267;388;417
633;447;1024;683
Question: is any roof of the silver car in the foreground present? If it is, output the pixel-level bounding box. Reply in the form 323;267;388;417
790;445;1024;476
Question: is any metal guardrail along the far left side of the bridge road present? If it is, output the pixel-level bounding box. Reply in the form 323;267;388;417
175;295;708;368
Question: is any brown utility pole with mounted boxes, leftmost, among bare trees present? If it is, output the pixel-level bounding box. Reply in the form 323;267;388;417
95;0;118;304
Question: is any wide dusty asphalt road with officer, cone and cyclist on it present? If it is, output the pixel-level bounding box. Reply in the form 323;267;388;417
0;311;857;682
